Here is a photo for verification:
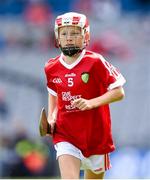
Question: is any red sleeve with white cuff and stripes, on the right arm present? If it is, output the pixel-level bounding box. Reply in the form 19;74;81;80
95;55;126;90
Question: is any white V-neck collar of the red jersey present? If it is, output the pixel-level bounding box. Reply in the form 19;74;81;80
59;49;86;69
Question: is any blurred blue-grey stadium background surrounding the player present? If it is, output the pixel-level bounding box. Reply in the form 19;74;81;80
0;0;150;179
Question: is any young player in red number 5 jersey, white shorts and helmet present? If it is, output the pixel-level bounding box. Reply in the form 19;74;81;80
45;12;125;179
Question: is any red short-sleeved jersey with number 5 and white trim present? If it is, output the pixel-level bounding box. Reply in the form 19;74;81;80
45;50;125;157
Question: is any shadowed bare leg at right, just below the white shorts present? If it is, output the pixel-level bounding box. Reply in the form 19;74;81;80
84;169;105;179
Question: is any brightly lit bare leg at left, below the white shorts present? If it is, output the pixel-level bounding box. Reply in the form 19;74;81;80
58;154;81;179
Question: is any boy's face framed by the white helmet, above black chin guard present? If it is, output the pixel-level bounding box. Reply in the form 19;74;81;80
58;26;84;48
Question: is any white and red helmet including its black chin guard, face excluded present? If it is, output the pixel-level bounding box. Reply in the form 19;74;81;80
54;12;90;56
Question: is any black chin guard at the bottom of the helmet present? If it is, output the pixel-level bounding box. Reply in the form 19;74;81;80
60;46;83;57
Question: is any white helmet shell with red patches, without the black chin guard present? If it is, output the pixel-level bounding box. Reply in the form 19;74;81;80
54;12;90;48
